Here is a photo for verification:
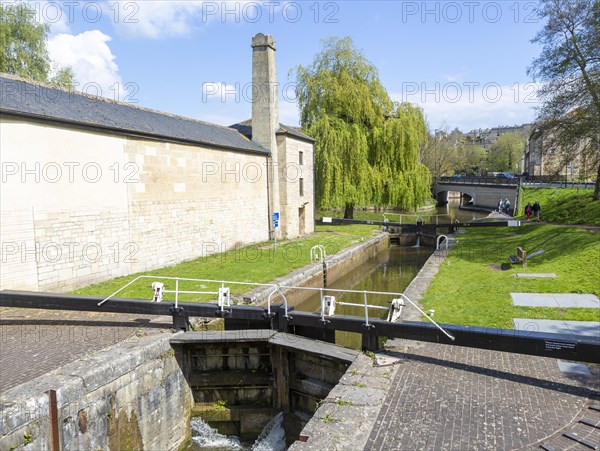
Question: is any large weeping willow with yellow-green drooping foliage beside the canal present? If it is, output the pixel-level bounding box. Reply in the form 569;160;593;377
296;37;431;218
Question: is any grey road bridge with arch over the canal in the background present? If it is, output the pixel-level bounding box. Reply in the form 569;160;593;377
432;177;519;208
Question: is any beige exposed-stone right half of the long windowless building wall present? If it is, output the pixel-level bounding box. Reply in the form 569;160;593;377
126;140;269;272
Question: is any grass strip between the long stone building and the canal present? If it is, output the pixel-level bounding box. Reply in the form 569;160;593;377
71;224;378;302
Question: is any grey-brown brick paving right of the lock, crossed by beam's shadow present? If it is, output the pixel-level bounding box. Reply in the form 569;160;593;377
365;340;600;451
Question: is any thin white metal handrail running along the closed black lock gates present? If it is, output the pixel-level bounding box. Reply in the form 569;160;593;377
98;275;454;341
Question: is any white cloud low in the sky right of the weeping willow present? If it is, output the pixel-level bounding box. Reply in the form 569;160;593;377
391;82;539;132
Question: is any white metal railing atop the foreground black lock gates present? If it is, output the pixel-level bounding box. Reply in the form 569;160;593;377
98;275;454;341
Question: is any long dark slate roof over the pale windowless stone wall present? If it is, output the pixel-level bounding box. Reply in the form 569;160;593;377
0;74;270;155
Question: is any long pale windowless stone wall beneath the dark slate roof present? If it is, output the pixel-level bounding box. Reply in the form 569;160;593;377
0;117;269;292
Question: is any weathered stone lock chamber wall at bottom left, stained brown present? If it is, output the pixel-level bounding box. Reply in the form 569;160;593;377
0;334;192;451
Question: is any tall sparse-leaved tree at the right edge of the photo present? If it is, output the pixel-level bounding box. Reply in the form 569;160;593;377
528;0;600;200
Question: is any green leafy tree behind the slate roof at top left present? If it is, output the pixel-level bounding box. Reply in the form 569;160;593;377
0;3;73;89
